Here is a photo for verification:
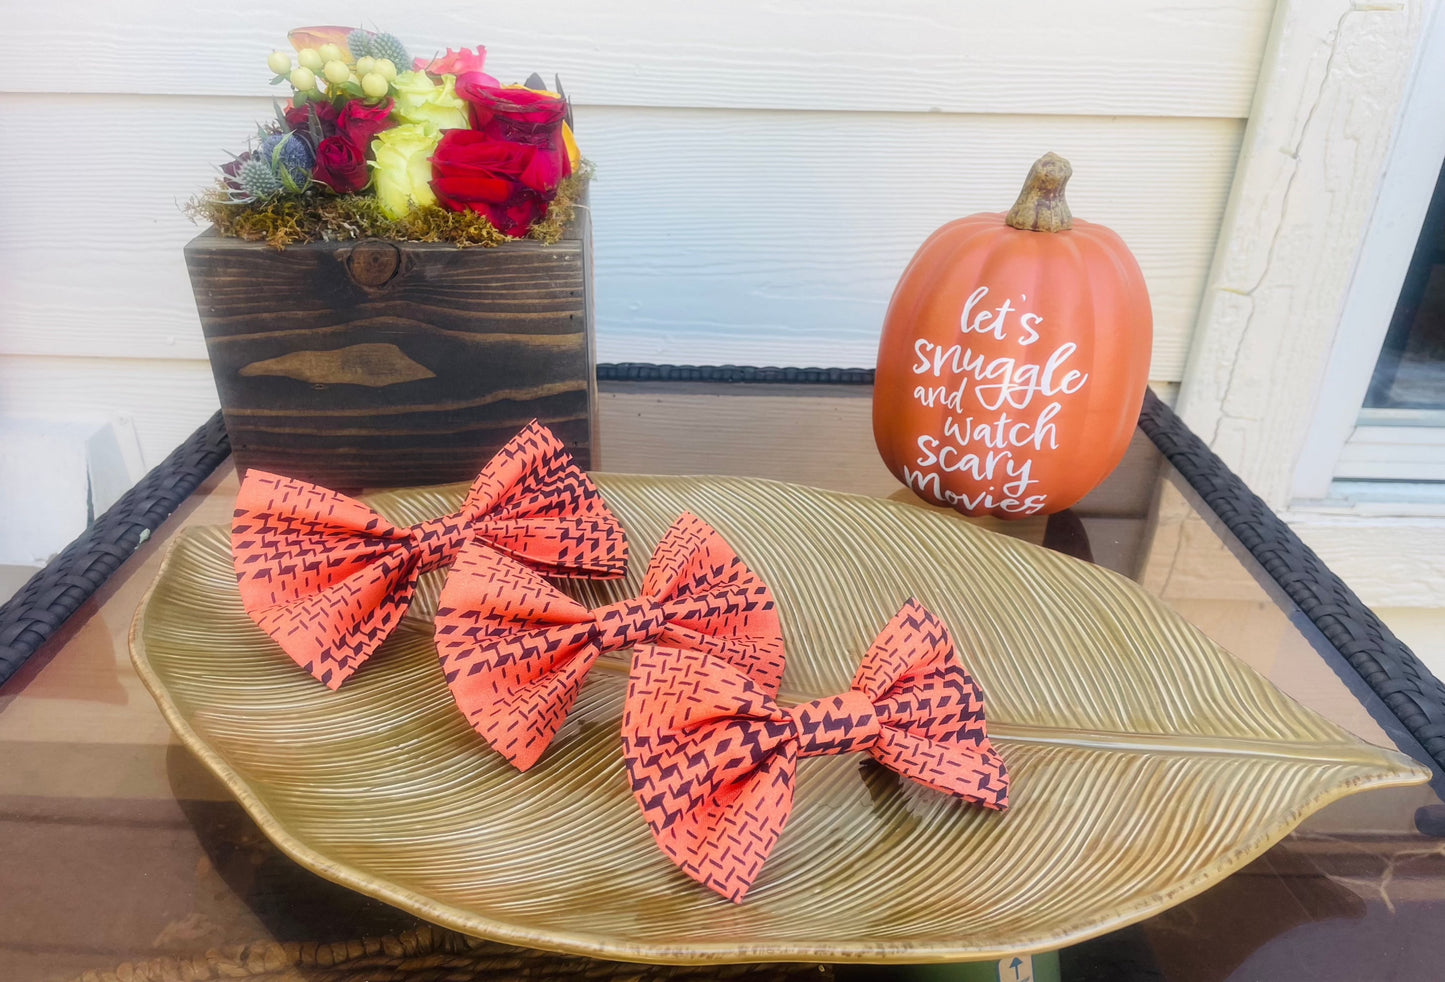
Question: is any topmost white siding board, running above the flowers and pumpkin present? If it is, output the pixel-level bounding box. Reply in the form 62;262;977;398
0;0;1273;117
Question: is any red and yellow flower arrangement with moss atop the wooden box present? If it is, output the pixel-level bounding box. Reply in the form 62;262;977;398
189;27;587;248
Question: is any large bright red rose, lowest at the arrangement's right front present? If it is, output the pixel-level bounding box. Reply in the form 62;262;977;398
432;130;556;238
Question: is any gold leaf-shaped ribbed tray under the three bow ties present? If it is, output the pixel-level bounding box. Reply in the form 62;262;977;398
131;475;1429;963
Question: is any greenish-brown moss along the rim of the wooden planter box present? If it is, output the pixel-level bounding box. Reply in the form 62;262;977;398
185;162;592;250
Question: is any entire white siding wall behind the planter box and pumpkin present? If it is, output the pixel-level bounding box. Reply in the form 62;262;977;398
0;0;1273;466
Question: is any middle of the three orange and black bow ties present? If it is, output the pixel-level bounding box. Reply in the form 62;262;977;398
436;514;783;771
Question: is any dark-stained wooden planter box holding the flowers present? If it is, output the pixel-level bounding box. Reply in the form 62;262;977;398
185;211;597;488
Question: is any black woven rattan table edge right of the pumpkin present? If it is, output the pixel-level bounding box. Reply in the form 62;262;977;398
1139;393;1445;767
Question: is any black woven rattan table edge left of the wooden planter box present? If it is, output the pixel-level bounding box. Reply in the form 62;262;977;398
0;412;231;683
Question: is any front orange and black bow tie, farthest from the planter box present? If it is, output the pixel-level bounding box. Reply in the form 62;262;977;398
623;601;1009;903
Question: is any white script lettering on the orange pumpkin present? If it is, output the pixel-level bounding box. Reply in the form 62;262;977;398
903;286;1088;514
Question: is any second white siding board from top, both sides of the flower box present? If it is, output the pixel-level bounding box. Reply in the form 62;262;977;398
0;95;1243;372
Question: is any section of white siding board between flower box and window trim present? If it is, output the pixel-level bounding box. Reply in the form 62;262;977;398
584;111;1243;369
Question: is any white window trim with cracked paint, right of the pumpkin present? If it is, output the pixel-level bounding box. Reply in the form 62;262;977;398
1176;0;1445;516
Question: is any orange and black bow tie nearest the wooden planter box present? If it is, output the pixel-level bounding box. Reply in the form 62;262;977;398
231;420;627;689
